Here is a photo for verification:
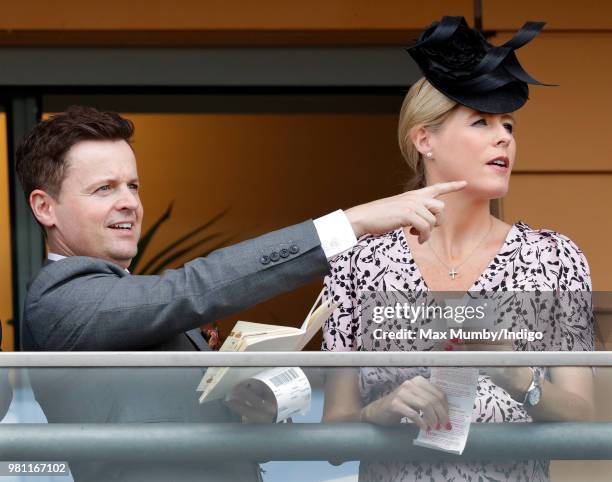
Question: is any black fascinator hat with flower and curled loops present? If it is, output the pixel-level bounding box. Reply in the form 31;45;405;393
406;17;546;114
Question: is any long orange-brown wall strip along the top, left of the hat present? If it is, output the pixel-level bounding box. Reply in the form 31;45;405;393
0;0;472;30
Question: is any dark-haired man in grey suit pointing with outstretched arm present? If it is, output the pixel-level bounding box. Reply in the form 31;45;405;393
17;107;463;480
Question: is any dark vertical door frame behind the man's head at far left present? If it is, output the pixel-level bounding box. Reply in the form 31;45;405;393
5;96;45;350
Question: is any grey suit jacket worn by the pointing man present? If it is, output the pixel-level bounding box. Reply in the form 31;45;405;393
23;221;329;480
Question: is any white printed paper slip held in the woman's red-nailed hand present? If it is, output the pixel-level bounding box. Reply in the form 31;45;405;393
414;367;478;455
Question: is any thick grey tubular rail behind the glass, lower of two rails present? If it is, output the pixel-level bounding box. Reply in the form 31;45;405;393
0;422;612;463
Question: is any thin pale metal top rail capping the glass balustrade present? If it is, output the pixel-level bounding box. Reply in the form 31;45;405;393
0;351;612;368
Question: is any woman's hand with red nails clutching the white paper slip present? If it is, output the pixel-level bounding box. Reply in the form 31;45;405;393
361;376;452;430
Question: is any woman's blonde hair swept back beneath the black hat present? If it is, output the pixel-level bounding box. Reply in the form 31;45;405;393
397;77;458;190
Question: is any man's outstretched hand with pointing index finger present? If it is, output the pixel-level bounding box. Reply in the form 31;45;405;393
345;181;467;244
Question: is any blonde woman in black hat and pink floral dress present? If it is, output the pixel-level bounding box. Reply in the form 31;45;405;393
323;17;593;481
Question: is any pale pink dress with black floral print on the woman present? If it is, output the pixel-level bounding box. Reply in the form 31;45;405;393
323;222;593;482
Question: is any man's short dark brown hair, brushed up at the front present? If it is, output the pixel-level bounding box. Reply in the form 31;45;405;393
15;105;134;199
